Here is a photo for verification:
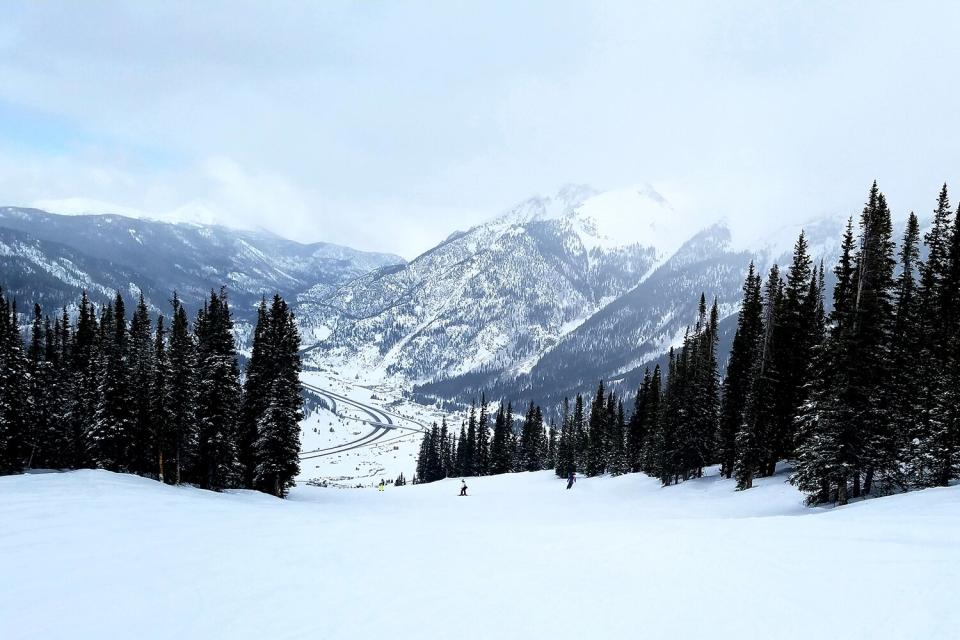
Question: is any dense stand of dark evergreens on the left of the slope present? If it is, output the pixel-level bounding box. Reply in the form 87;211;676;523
0;289;303;497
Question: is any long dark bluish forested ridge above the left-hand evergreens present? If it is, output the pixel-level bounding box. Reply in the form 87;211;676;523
0;207;403;319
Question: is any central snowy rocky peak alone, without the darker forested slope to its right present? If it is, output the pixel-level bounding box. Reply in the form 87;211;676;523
299;187;692;382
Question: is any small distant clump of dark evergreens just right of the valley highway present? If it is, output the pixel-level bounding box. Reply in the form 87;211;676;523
413;397;557;484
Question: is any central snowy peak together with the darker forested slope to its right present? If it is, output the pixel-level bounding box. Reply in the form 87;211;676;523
299;185;841;404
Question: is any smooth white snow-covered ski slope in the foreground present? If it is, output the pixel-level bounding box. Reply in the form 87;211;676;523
0;471;960;640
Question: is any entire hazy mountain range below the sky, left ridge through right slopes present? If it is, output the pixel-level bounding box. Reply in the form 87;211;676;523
0;185;845;401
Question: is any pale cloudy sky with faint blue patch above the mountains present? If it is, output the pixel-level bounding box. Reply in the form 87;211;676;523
0;0;960;258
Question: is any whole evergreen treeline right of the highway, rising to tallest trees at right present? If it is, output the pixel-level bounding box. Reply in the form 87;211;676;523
418;183;960;504
